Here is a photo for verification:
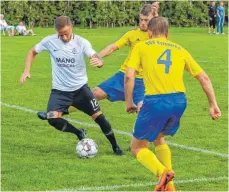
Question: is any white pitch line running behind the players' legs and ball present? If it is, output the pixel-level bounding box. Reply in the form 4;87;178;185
0;102;229;158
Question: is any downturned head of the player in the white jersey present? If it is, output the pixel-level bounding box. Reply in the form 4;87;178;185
54;16;72;42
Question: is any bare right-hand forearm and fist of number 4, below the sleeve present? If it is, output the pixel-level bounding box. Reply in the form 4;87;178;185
196;71;221;120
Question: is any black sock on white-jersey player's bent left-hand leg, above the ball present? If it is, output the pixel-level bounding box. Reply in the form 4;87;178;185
48;118;82;139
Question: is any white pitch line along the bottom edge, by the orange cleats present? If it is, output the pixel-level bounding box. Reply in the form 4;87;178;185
58;176;228;191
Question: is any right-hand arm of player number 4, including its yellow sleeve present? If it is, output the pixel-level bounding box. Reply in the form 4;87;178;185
184;51;221;120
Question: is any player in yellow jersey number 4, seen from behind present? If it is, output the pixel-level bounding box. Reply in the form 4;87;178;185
125;17;221;191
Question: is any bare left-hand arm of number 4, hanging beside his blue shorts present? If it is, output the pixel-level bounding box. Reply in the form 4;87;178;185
124;68;137;113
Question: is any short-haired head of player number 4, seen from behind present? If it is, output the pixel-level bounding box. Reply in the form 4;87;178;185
148;17;169;38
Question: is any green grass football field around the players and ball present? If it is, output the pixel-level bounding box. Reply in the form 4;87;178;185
1;28;228;191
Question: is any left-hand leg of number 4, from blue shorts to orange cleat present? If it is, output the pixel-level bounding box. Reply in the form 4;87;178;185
131;95;178;191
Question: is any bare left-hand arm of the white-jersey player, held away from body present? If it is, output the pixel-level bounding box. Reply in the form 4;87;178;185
20;48;37;84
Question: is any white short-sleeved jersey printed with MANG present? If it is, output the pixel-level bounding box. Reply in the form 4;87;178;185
35;34;96;91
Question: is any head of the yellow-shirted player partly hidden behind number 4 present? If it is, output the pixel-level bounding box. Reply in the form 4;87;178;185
139;4;155;31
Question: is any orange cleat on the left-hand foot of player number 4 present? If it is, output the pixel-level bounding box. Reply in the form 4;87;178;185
154;170;175;192
